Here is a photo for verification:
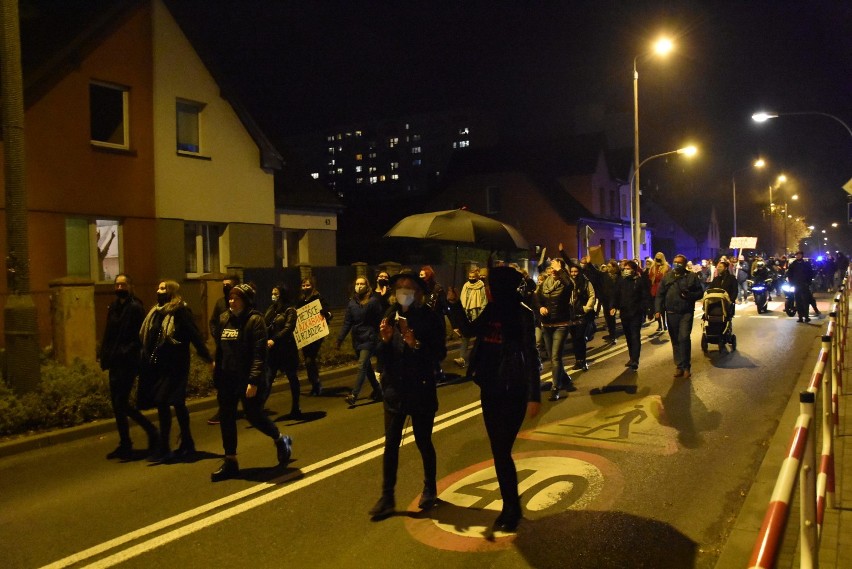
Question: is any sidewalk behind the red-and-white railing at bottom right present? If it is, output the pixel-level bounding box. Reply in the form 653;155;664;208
716;318;852;569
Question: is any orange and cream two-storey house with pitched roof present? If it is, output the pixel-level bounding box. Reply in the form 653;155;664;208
0;0;298;345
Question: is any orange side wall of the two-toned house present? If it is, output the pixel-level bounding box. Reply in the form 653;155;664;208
0;4;157;346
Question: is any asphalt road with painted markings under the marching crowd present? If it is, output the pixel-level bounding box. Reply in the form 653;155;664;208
0;303;825;569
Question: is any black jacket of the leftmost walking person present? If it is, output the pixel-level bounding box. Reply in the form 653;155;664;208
98;296;145;369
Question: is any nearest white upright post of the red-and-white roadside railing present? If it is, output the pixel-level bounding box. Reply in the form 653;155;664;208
799;391;819;569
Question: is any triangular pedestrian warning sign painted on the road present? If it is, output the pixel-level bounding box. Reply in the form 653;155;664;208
518;395;678;455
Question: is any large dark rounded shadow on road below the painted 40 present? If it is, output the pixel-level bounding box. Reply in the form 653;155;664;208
515;510;698;569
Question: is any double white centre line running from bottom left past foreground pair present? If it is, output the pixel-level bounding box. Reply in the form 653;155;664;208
42;400;482;569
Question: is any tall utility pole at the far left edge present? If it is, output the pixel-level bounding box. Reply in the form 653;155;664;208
0;0;41;393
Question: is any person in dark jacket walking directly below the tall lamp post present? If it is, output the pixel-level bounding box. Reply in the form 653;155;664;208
610;259;652;371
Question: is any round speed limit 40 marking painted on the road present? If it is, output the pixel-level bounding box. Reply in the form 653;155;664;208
405;450;624;552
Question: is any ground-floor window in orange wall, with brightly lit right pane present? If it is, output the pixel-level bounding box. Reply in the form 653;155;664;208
65;217;122;282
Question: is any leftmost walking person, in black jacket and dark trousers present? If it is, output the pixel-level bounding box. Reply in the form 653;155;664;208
98;273;160;460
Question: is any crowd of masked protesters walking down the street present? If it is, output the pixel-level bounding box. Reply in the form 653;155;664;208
99;248;849;531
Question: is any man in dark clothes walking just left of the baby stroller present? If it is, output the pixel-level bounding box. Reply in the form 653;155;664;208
654;254;704;379
